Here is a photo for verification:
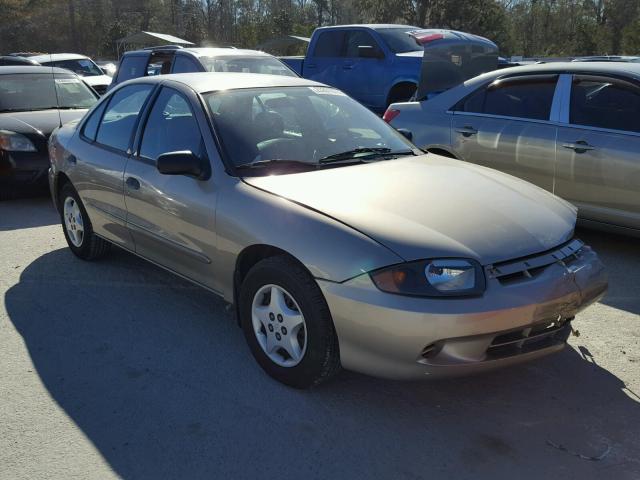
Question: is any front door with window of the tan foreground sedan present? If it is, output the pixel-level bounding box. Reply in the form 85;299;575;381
124;86;216;287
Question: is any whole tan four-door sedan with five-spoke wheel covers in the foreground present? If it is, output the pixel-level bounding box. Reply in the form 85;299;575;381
50;73;607;387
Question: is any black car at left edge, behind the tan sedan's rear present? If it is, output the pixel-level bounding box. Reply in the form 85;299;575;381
0;66;98;198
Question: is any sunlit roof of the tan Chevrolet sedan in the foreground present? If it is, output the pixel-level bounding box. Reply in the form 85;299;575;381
122;72;324;93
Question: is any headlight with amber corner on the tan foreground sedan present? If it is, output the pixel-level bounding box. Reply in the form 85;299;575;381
369;258;485;297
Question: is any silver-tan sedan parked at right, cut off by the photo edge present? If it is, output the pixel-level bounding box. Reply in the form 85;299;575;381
385;62;640;234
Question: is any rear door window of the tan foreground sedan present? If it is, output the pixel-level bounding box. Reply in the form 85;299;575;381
96;84;153;151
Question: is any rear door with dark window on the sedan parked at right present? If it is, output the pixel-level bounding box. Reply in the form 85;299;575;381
451;75;559;191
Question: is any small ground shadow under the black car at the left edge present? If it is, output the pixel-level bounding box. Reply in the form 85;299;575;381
0;195;60;232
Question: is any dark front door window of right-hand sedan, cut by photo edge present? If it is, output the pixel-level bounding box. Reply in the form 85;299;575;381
569;75;640;133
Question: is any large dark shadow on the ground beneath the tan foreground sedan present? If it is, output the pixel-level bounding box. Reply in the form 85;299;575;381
5;249;640;479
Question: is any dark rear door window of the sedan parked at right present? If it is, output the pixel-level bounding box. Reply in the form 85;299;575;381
455;75;558;120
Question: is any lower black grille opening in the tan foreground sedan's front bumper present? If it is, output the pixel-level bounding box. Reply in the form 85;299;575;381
487;318;572;358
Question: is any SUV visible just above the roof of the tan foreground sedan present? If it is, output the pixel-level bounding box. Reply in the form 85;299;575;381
112;45;297;87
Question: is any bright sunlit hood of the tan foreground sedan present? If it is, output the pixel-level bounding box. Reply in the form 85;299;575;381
244;154;576;265
